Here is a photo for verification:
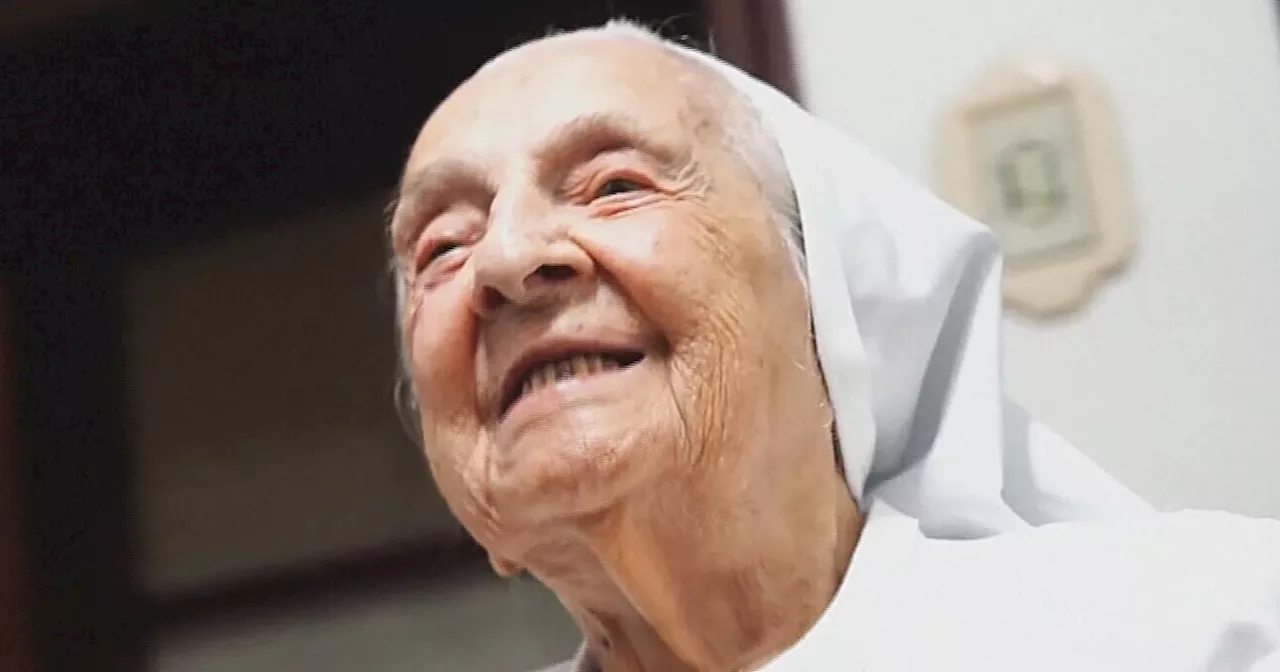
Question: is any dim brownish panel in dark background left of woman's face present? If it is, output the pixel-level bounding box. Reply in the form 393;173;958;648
127;194;458;590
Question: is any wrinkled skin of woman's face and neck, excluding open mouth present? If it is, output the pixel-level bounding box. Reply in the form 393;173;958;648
392;28;858;672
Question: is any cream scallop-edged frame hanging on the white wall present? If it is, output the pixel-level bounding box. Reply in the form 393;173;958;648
937;60;1135;319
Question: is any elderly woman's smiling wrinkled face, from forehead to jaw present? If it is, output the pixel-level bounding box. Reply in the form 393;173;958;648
392;31;826;564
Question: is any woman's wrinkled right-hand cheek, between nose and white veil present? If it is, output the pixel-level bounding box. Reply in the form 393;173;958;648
576;204;769;463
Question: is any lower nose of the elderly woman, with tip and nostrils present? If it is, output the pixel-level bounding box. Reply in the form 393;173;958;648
471;216;595;317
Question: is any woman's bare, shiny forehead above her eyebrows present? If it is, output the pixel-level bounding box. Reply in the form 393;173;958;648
406;36;704;174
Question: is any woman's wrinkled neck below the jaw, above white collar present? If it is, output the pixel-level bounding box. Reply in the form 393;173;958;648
529;453;863;672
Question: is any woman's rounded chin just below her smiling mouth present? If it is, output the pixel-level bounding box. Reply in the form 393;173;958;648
488;356;682;525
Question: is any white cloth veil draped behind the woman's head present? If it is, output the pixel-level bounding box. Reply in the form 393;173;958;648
676;46;1149;538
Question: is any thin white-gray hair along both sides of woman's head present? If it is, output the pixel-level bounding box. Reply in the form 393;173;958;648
392;19;808;444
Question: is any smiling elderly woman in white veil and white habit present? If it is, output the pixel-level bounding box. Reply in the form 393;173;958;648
390;23;1280;672
